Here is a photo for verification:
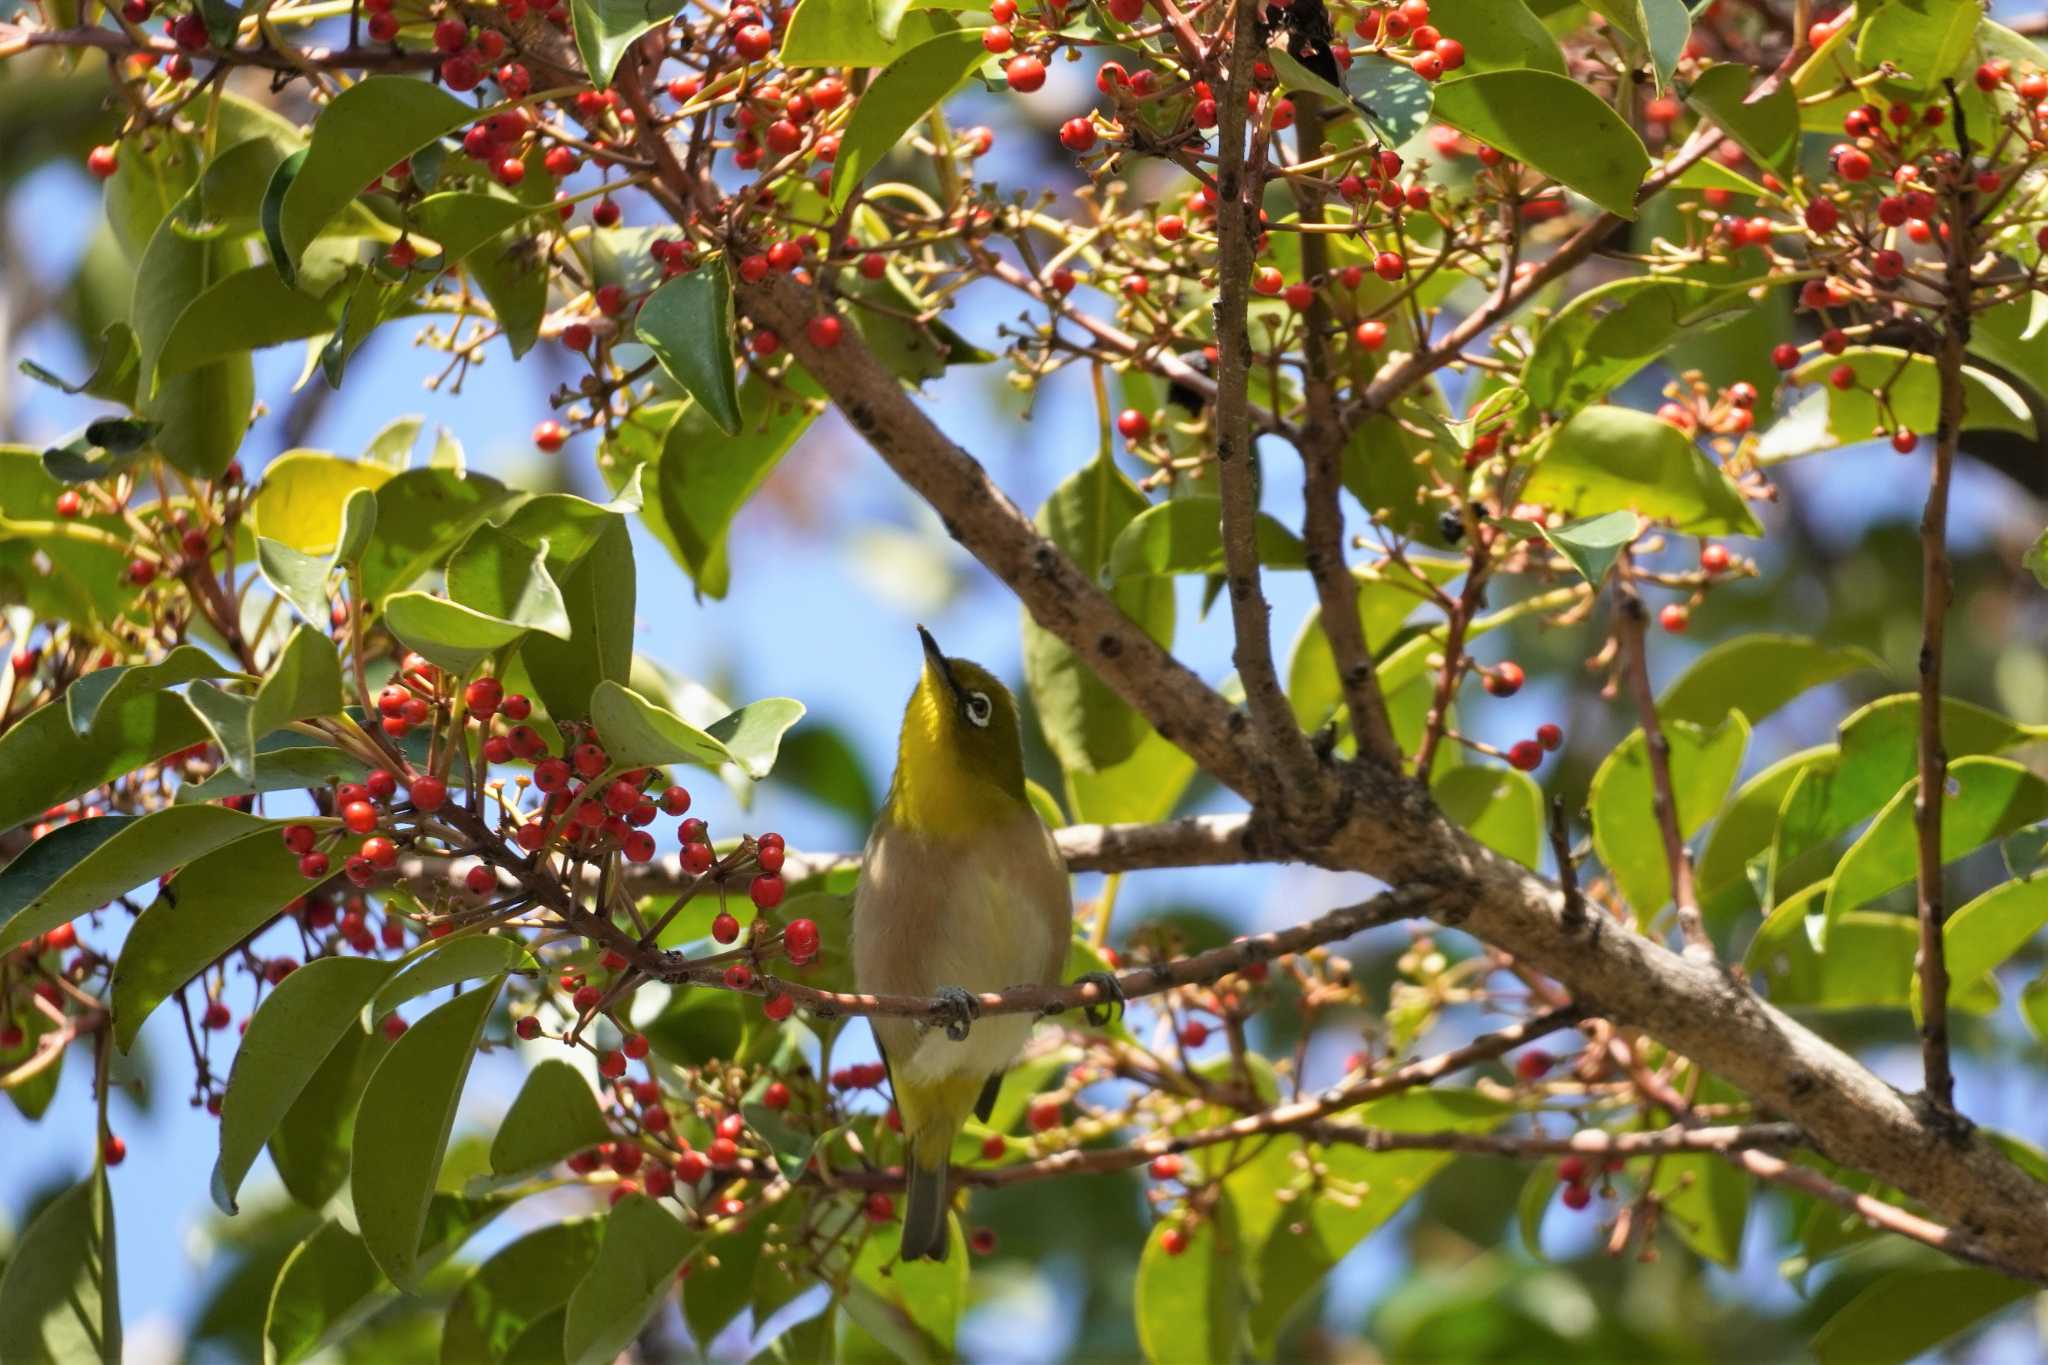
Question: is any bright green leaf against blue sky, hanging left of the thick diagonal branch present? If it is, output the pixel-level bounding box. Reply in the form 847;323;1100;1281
641;379;815;598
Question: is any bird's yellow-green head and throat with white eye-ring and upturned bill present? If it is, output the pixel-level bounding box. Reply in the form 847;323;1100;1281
897;626;1024;818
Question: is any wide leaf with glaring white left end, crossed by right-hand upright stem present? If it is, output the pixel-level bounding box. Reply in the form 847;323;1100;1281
1757;346;2036;465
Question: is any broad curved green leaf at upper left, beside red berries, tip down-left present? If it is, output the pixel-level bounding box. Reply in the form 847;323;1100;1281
272;76;475;278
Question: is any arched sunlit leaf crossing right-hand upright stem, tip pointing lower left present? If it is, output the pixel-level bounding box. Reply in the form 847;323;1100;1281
1827;757;2048;921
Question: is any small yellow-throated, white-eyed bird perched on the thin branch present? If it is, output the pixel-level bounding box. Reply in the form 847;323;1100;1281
852;626;1073;1261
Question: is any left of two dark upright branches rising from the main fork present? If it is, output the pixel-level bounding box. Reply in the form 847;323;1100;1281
1294;94;1401;767
